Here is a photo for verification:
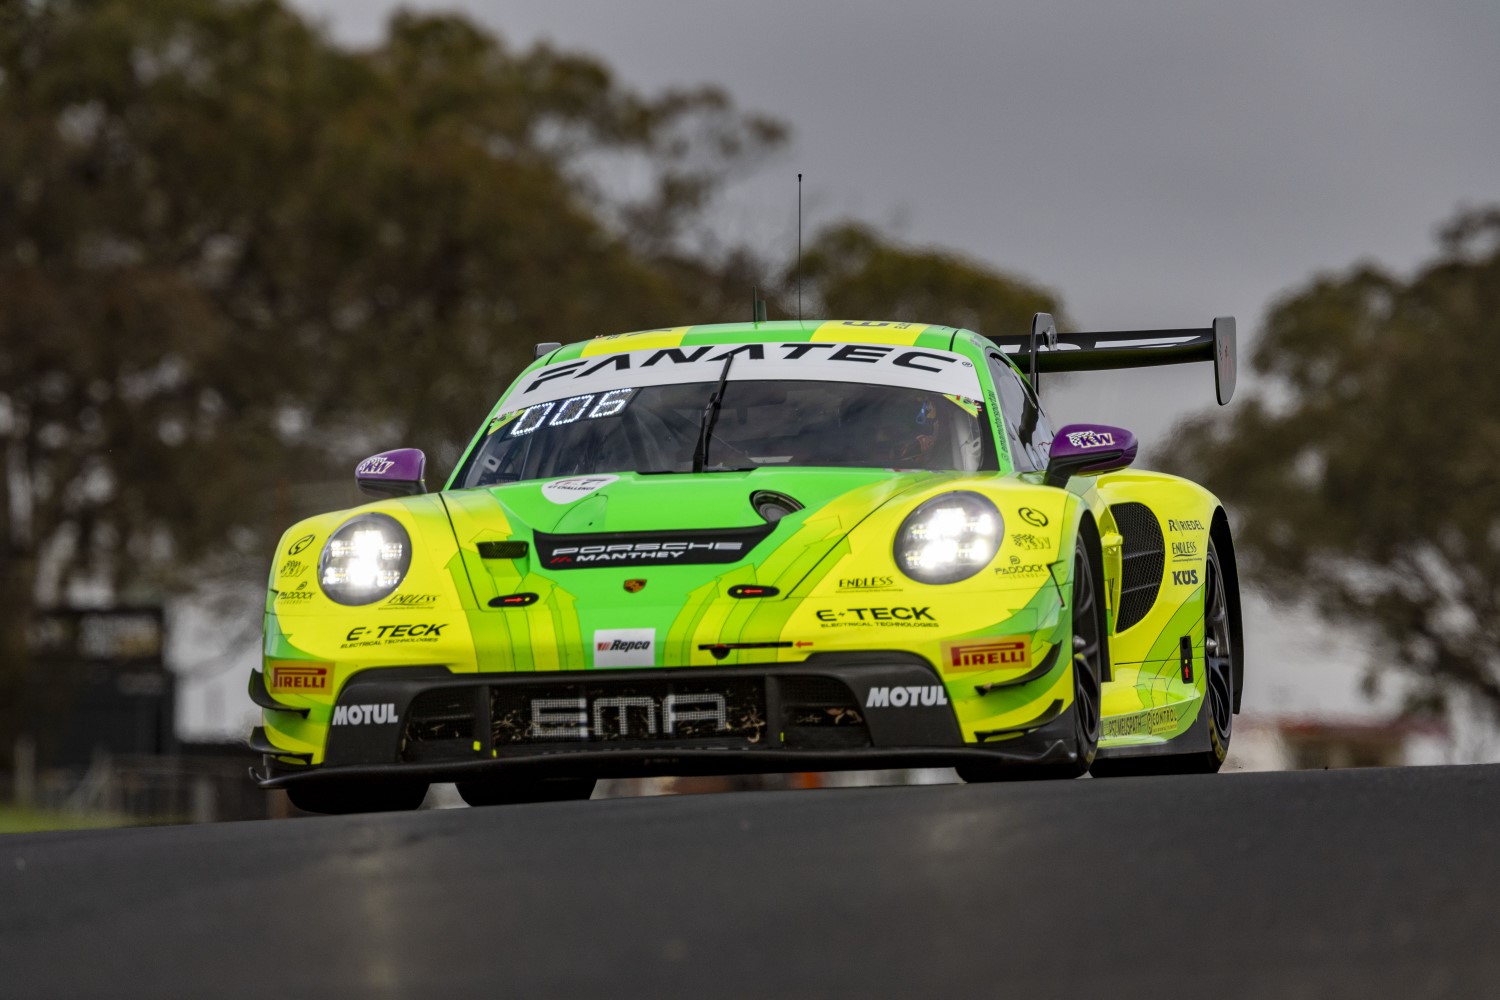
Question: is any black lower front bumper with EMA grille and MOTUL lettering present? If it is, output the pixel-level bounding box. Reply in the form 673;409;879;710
251;651;1073;789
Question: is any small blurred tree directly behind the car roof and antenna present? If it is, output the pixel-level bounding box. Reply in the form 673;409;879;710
798;222;1067;337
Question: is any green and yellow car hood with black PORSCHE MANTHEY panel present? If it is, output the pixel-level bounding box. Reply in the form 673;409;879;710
443;468;963;607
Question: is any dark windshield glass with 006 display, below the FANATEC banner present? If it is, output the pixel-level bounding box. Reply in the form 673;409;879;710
459;379;986;486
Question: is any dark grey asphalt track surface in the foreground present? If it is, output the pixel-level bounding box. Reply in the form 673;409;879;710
0;766;1500;1000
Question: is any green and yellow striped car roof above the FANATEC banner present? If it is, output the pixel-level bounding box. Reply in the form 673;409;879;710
548;319;960;363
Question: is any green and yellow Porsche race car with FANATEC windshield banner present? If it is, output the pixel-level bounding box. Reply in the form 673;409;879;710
249;313;1244;813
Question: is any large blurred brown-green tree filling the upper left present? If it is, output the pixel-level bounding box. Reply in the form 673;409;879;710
0;0;783;756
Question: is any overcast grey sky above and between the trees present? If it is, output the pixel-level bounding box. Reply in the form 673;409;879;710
196;0;1500;743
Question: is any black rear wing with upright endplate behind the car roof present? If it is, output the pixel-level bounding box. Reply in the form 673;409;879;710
998;312;1236;406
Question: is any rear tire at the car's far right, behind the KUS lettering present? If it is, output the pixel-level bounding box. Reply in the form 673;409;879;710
1092;538;1238;778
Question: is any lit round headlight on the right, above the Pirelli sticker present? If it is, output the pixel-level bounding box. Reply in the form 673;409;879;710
896;493;1005;583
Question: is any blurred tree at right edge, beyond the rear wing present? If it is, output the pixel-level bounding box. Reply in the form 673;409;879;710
1170;207;1500;712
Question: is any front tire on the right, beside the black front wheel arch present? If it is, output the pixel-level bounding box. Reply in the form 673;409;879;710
956;537;1107;783
